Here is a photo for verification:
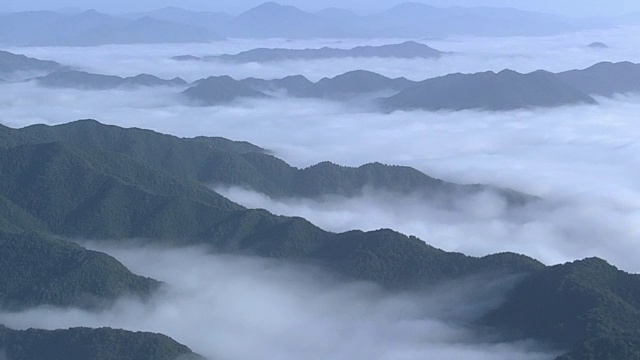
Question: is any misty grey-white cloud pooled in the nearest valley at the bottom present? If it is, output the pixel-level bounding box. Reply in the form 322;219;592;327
0;245;554;360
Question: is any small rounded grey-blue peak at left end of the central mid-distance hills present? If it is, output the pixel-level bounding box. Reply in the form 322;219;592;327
182;76;269;106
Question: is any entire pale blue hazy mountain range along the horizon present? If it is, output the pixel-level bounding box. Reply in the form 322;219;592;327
0;2;627;46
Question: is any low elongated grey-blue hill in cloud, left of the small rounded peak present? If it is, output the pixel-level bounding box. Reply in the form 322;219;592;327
32;71;187;90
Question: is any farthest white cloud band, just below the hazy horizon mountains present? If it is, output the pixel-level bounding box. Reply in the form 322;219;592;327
4;27;640;81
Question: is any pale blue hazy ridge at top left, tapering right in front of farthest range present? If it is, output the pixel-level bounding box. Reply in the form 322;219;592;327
0;10;221;46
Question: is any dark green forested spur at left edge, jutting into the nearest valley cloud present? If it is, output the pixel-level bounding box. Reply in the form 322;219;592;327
0;232;159;310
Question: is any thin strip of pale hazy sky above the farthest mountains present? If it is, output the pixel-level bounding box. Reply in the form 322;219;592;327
0;0;640;16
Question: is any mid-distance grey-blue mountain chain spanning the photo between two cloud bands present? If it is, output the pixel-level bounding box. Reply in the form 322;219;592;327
0;47;640;112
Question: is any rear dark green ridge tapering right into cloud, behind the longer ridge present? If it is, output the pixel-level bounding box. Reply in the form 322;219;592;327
0;120;532;204
